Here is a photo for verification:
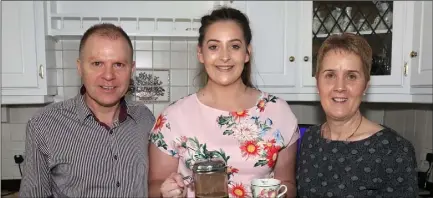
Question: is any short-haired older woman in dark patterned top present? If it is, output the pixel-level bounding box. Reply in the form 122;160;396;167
296;33;418;198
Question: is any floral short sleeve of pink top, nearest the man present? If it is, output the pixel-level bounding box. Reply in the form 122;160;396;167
149;111;178;157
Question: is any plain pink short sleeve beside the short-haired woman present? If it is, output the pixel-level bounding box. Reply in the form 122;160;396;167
275;99;300;147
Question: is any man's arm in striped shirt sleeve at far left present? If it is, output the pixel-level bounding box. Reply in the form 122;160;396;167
19;120;52;197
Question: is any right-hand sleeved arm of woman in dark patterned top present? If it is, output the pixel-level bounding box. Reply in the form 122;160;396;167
382;139;419;198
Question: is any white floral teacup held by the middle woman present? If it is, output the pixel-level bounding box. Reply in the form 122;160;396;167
251;179;287;198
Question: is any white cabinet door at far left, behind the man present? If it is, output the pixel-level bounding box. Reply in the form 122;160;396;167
1;1;38;89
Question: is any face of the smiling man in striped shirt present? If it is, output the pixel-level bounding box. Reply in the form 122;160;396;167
77;34;135;107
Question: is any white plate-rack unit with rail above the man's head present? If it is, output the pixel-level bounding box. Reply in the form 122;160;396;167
47;1;216;38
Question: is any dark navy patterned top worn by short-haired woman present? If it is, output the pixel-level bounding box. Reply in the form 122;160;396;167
296;125;418;198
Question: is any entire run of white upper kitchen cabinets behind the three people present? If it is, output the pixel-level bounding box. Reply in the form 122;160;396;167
2;1;432;103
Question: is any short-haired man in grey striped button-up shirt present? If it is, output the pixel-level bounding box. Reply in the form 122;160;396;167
20;24;155;197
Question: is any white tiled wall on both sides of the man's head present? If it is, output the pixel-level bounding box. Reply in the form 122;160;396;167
53;38;204;113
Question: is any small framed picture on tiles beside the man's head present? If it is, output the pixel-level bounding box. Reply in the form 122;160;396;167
129;69;170;103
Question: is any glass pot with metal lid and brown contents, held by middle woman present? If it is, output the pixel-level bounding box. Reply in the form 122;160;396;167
192;155;228;198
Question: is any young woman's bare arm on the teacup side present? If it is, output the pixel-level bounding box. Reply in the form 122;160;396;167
274;142;297;197
